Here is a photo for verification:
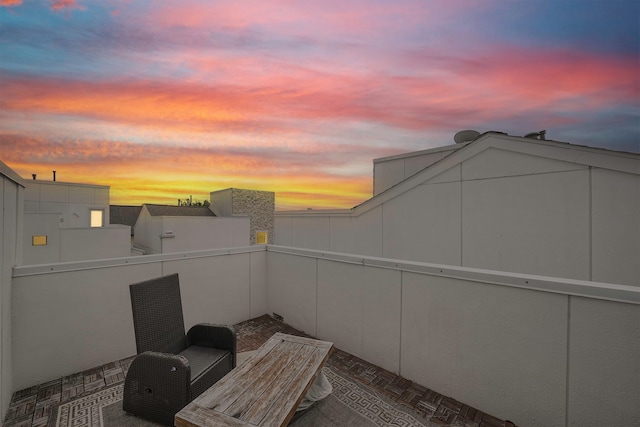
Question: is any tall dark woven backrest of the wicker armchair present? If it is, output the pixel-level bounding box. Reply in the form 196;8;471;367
129;273;187;354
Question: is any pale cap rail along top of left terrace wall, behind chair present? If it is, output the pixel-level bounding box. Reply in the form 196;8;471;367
13;246;266;277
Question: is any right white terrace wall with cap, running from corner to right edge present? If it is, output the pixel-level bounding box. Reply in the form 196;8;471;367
267;247;640;427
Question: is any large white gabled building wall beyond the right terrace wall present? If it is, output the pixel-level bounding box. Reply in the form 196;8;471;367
275;141;640;286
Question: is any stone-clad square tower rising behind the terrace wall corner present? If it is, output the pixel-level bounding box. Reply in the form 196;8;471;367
211;188;275;245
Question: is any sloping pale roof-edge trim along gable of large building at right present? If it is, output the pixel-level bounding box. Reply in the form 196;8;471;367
349;132;640;216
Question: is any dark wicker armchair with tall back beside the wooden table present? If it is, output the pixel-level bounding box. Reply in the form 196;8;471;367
122;274;236;426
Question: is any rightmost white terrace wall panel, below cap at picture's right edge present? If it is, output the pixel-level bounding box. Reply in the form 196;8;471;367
567;297;640;427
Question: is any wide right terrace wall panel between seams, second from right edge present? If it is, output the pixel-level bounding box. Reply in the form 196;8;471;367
400;273;568;426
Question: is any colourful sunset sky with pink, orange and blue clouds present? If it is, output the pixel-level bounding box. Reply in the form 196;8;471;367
0;0;640;210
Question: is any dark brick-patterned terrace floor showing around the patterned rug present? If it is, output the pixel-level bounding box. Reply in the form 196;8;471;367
3;315;515;427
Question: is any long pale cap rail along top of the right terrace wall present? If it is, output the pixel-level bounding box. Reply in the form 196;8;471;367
267;245;640;304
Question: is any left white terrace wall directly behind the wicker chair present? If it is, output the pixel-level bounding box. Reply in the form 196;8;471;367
12;246;266;392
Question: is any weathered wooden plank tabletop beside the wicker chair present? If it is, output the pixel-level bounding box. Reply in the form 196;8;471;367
175;332;333;427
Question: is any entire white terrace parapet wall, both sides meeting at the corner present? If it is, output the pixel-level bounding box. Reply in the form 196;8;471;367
12;246;640;425
